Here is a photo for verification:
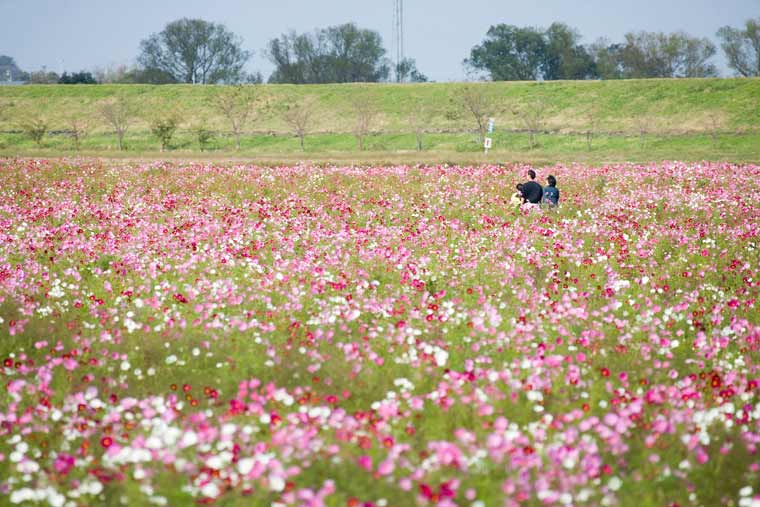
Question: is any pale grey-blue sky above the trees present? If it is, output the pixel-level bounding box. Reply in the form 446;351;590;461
0;0;760;81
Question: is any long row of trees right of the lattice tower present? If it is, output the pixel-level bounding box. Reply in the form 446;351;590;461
464;18;760;81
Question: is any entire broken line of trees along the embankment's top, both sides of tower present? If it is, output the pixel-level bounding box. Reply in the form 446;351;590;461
0;18;760;84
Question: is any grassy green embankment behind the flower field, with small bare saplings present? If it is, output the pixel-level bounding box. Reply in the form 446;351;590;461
0;79;760;163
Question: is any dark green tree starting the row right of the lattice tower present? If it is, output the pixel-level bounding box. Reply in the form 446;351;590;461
464;24;546;81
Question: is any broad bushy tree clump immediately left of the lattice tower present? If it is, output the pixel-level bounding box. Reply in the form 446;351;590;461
265;23;390;84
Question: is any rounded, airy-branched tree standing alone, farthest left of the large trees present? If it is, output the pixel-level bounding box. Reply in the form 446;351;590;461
137;18;251;84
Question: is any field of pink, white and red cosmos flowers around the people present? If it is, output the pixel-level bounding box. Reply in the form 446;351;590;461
0;160;760;507
